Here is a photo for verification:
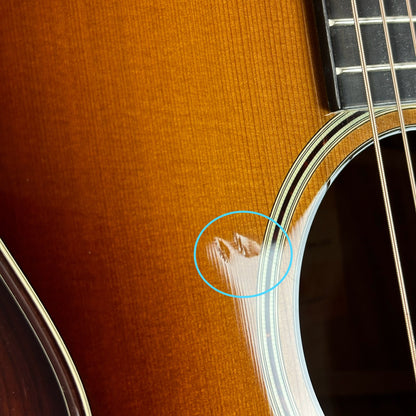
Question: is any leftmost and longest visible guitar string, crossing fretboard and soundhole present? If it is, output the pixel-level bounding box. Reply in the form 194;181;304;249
351;0;416;381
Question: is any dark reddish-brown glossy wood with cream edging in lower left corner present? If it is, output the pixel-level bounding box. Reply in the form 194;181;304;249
0;241;91;416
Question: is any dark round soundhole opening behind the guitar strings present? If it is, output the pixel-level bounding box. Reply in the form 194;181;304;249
299;132;416;416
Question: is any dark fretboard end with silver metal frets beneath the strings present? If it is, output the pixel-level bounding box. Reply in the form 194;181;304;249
315;0;416;110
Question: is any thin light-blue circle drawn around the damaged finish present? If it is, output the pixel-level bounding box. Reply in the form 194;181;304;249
194;210;293;299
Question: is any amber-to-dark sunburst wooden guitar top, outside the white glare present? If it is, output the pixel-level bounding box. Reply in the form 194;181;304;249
0;0;416;416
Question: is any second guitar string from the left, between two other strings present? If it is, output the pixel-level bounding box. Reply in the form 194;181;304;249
379;0;416;210
